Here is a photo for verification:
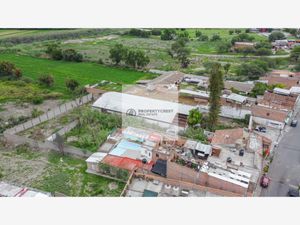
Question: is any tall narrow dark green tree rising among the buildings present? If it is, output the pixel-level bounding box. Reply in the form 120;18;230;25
208;63;224;131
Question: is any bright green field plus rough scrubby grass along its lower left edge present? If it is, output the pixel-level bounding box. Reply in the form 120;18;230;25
0;54;153;101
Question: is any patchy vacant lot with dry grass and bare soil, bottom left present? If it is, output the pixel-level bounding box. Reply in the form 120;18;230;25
0;145;125;197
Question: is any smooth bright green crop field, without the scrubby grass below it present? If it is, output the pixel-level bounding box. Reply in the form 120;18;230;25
0;54;153;95
